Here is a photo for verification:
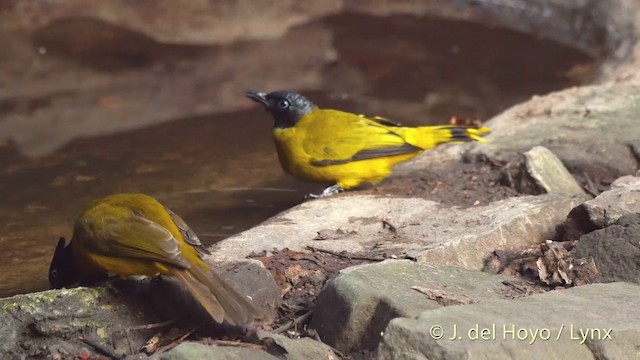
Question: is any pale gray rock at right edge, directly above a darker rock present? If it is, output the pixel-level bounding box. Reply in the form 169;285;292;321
584;176;640;228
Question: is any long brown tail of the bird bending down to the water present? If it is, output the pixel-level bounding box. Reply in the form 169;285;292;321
175;265;264;325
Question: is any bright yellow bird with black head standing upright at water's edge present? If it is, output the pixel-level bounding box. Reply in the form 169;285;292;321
246;91;489;197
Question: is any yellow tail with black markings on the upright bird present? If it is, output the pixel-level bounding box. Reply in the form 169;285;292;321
402;125;491;150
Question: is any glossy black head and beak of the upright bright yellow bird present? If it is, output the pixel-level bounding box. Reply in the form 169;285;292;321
246;91;317;129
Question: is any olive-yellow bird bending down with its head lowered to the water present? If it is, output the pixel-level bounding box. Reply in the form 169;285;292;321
49;194;263;325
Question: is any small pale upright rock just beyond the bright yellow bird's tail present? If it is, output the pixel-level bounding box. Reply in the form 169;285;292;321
505;146;585;195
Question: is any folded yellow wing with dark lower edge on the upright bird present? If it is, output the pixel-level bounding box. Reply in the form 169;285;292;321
303;110;421;166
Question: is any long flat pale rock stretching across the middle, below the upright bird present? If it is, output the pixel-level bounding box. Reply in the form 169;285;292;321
212;194;584;270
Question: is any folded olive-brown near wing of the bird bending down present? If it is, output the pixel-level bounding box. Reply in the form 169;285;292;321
75;209;190;268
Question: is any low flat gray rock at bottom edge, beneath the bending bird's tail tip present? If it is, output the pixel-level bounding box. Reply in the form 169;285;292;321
160;341;278;360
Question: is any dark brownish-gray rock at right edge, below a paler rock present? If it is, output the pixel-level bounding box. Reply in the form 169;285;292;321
571;213;640;283
